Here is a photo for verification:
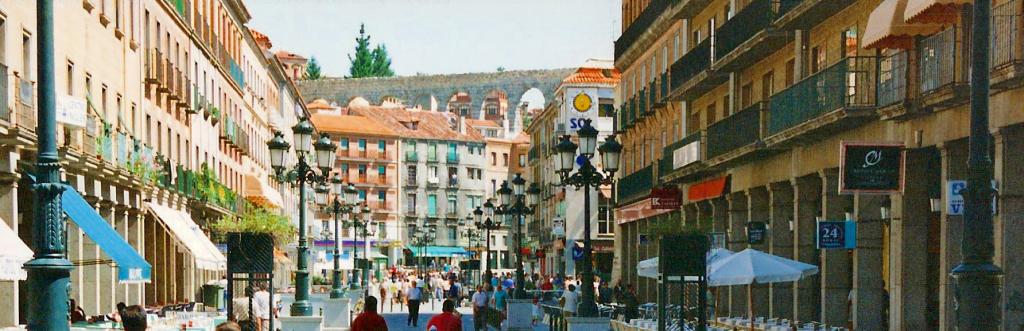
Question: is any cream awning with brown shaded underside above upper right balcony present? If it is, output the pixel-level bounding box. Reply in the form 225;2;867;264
863;0;942;49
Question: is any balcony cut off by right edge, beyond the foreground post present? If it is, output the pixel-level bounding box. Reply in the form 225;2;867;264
991;0;1024;89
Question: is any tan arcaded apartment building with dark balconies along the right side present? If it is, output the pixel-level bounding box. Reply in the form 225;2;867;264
614;0;1024;330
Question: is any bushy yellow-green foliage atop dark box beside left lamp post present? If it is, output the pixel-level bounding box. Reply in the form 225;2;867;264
213;208;296;244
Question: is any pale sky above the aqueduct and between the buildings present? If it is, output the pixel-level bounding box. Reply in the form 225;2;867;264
245;0;622;76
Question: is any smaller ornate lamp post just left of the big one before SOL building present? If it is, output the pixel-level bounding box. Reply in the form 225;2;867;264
498;173;540;299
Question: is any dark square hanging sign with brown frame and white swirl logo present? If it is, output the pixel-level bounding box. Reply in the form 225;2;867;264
839;141;904;194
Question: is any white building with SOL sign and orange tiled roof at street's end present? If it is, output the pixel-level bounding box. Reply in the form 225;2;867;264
520;59;620;280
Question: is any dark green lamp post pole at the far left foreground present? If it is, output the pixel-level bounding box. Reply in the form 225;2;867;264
25;0;72;330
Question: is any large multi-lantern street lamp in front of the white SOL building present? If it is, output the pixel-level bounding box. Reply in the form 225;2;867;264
555;120;623;317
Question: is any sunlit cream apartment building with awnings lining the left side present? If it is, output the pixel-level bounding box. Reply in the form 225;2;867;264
0;0;305;326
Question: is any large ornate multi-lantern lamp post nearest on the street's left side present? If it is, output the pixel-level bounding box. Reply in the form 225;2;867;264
266;118;337;316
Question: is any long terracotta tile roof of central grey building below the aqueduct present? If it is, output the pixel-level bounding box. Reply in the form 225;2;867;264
348;106;483;142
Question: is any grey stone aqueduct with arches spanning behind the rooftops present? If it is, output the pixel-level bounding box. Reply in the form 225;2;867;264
298;69;574;118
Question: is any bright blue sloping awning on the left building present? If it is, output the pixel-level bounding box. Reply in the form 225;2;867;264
60;185;153;283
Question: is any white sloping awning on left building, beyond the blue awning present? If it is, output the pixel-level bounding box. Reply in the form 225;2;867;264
146;202;227;271
